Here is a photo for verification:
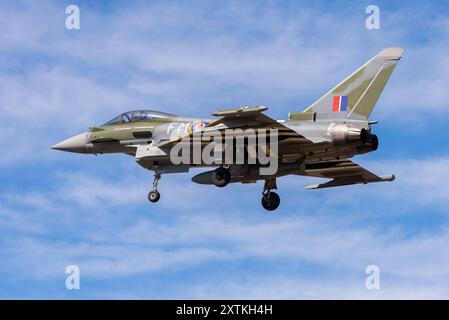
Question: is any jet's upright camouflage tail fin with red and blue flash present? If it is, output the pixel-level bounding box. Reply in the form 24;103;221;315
303;48;404;119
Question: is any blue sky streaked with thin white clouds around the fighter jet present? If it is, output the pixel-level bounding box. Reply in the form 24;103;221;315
0;1;449;299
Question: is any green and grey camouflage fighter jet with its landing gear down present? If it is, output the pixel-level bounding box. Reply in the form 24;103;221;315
52;48;403;211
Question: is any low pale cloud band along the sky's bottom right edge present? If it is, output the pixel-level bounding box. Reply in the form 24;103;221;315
183;276;448;300
